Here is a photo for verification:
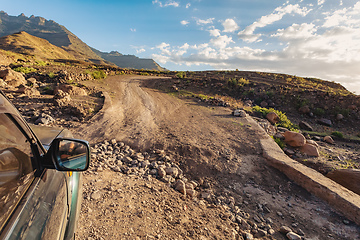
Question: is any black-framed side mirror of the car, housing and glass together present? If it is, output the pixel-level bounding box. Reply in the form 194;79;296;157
45;138;90;171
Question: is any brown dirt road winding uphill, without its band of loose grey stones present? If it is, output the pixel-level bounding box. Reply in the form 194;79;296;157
74;76;360;239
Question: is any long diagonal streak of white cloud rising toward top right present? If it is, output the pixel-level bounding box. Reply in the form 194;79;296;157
238;4;311;43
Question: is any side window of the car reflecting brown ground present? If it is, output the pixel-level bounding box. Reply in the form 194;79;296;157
0;113;34;230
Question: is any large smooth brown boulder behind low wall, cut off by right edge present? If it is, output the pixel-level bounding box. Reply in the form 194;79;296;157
326;169;360;195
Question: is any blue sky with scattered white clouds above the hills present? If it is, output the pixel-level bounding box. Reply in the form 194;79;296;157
0;0;360;94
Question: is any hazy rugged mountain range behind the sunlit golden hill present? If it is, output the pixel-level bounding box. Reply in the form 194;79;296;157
0;11;162;70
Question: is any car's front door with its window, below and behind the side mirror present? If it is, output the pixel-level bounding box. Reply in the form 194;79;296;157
0;94;69;239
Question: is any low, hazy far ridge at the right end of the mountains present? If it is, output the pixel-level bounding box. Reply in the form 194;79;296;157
91;48;165;71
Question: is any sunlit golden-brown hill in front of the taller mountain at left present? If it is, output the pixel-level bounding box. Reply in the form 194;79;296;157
0;32;75;60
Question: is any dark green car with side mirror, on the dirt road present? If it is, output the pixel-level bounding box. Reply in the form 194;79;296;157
0;90;90;239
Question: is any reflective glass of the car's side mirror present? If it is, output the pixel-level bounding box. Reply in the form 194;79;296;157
58;140;89;171
